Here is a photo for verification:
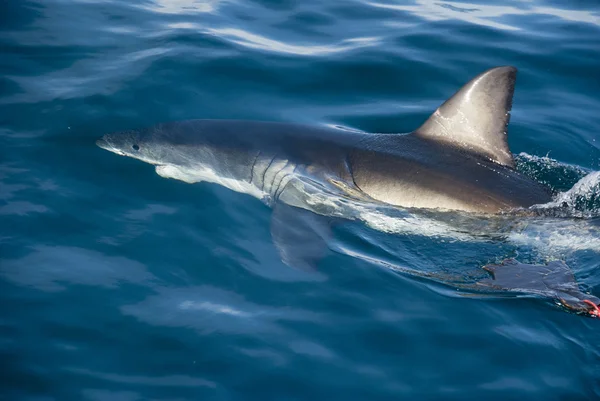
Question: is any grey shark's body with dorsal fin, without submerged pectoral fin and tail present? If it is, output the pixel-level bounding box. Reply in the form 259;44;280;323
97;66;551;214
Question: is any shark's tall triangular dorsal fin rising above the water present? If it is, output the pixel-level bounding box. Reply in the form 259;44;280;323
414;66;517;167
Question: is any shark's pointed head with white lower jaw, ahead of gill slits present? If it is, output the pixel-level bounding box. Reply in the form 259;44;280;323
96;120;262;189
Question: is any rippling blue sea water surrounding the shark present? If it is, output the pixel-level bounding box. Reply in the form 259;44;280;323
0;0;600;401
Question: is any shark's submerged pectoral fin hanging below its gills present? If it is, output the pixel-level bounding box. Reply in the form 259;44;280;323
271;202;331;270
